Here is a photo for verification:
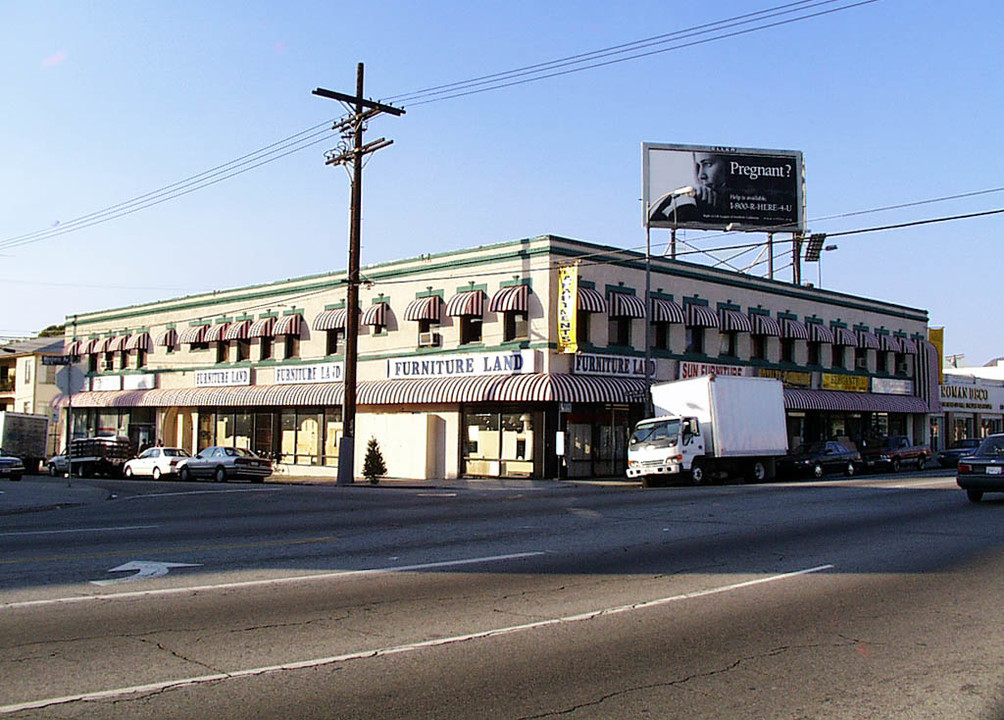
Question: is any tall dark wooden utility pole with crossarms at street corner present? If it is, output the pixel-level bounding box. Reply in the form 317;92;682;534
313;62;405;485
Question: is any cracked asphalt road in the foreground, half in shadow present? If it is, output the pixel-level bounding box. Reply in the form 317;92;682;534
0;471;1004;718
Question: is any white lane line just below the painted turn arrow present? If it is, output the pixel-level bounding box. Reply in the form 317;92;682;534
0;550;546;611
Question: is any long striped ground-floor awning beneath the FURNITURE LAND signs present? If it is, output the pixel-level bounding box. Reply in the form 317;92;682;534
55;374;646;408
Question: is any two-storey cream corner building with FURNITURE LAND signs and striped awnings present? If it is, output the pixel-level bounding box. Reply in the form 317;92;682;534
60;236;940;478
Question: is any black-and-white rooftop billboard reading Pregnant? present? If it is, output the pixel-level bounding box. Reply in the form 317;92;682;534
642;143;805;232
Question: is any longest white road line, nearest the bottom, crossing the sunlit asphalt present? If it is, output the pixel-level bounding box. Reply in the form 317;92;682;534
0;564;833;715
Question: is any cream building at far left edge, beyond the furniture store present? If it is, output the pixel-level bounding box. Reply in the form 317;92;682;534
0;337;67;451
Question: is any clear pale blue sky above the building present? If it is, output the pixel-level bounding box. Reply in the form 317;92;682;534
0;0;1004;365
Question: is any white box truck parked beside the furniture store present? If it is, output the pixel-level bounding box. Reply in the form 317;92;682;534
628;375;788;486
